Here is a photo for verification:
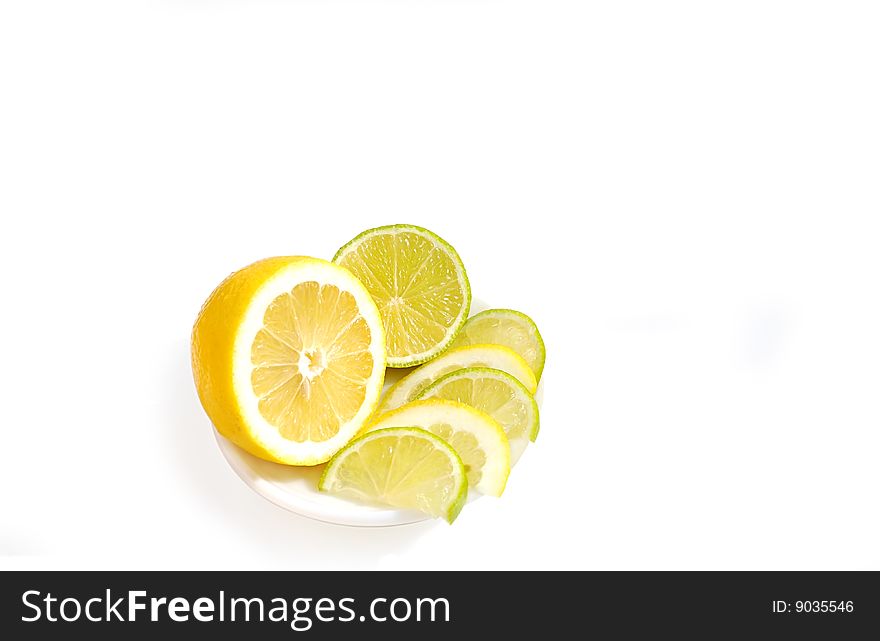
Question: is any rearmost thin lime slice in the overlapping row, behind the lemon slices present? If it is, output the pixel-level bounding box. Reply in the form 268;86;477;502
452;309;545;380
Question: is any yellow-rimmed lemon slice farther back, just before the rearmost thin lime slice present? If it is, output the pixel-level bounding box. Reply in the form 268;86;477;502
379;345;538;412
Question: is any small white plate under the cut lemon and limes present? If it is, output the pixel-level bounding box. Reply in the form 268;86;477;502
214;300;544;527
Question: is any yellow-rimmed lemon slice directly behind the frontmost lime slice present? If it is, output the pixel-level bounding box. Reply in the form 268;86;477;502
367;398;510;496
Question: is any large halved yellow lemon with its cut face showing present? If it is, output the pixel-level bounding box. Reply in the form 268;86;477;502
192;256;385;465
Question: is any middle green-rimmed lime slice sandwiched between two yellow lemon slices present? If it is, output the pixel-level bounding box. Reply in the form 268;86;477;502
418;367;538;465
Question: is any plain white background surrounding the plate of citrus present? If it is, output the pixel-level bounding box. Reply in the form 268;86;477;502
0;0;880;569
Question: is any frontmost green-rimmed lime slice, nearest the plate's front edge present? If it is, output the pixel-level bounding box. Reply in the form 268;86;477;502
318;427;468;523
